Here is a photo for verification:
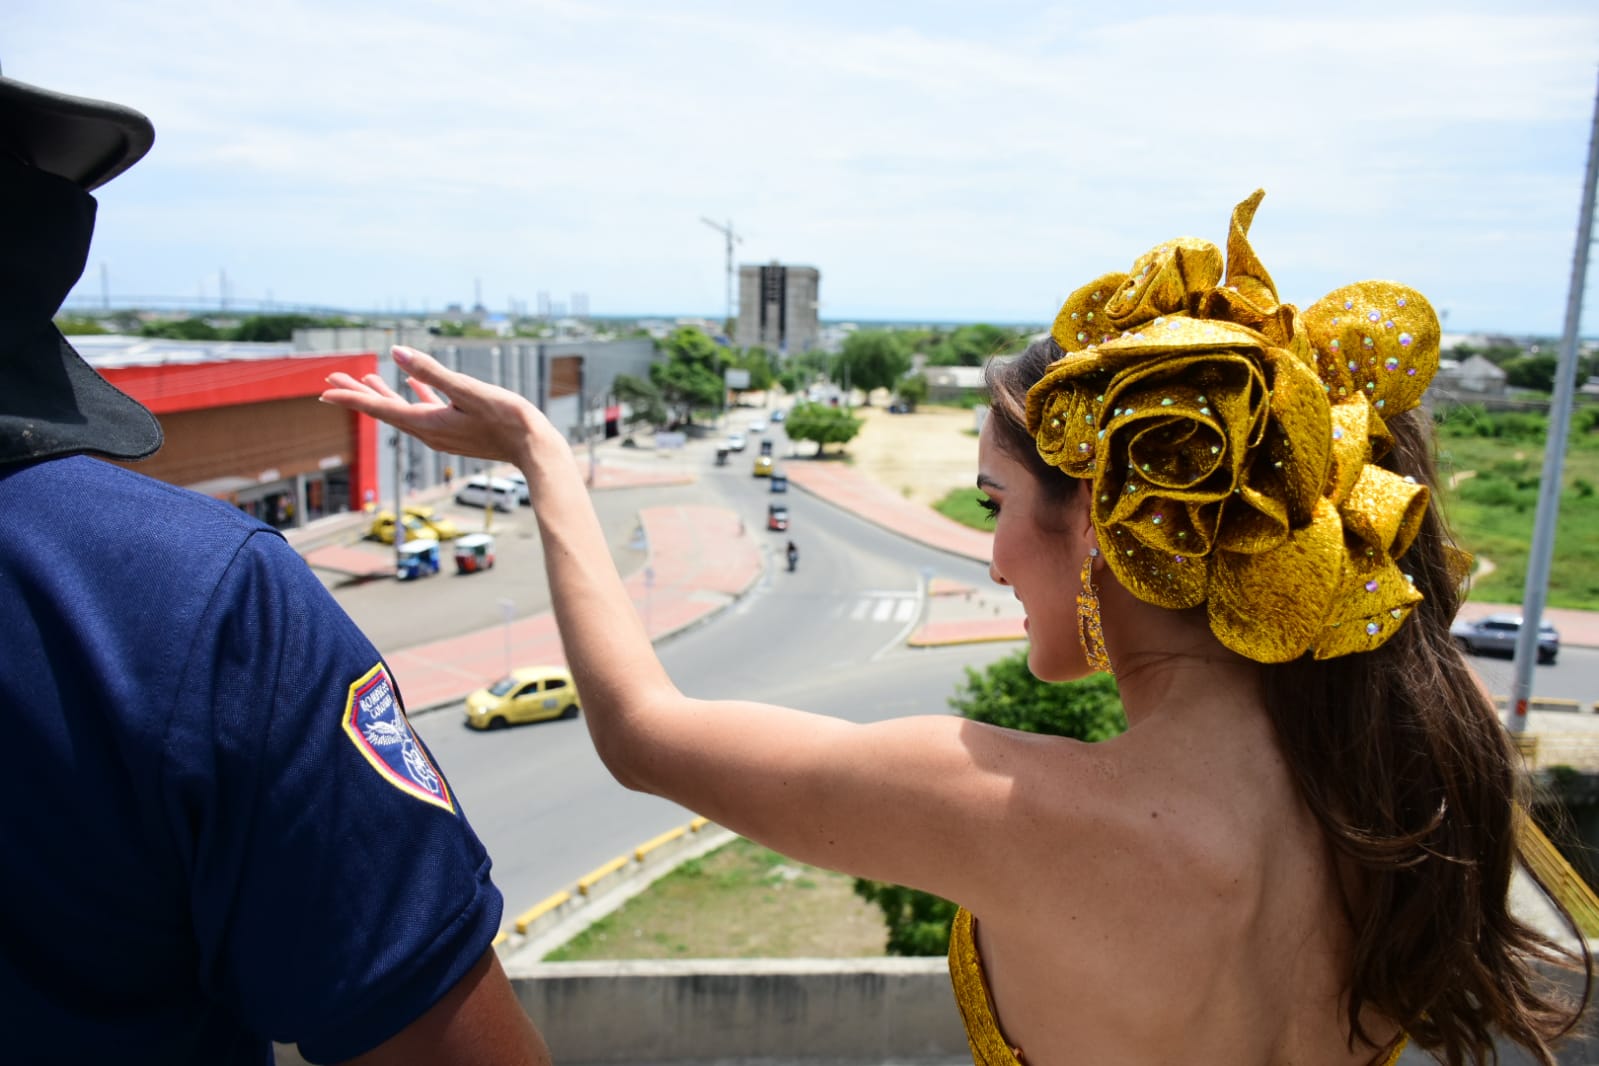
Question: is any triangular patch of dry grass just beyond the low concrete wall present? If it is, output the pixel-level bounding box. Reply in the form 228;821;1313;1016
545;837;887;962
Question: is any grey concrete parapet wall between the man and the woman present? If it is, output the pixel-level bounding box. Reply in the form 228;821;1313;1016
507;957;971;1066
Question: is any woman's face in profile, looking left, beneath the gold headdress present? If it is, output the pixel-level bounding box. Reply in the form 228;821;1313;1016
977;414;1091;681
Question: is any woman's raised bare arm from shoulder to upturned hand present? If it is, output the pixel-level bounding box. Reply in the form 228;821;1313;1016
323;348;1071;900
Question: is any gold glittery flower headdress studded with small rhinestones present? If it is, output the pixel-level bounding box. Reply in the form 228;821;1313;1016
1027;190;1439;663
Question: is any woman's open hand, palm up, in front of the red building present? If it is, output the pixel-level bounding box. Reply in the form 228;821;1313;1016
321;345;560;467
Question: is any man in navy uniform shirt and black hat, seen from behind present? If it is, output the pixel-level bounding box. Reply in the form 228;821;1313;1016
0;62;548;1066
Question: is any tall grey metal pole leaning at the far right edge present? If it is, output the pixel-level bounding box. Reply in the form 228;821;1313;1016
1509;68;1599;734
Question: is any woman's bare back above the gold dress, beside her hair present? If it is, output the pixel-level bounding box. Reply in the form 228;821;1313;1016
974;708;1396;1066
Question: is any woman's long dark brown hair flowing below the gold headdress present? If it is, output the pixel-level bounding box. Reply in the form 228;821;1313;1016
985;339;1593;1066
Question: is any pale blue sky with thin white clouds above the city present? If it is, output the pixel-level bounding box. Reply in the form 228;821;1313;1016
9;0;1599;337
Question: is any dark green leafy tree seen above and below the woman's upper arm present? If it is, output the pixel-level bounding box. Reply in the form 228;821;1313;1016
855;650;1127;956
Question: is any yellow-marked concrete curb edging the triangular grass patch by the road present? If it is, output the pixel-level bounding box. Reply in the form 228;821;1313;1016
494;818;737;962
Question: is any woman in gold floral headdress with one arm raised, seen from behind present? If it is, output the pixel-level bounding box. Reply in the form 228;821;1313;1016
325;193;1588;1066
